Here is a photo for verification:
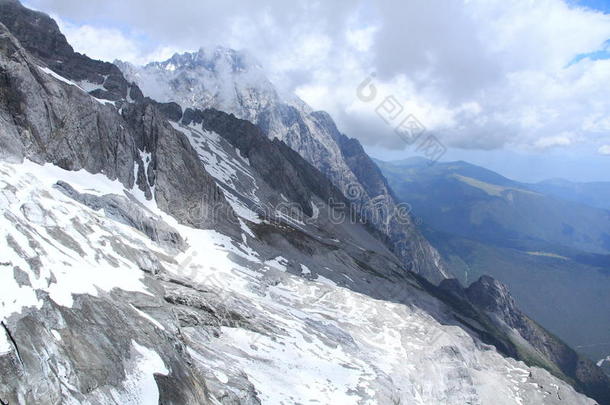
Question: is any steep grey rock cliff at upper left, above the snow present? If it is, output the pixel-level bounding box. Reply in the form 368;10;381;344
0;2;235;233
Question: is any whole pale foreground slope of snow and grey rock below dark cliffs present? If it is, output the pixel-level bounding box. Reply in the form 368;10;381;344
0;156;594;405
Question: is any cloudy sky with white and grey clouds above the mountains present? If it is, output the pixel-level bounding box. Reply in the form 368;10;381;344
25;0;610;180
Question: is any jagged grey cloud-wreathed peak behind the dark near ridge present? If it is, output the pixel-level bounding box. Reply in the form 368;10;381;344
115;47;449;283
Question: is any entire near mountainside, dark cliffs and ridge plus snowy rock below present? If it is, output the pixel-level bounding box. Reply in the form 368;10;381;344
0;0;605;405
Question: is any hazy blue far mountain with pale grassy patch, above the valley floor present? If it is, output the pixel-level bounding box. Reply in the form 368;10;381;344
380;159;610;254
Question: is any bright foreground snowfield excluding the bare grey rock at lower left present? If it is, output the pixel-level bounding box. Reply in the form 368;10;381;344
0;162;594;405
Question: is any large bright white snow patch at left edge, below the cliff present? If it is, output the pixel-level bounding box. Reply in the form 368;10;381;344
0;161;157;319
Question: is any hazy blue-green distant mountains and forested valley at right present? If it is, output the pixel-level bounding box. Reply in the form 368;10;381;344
376;158;610;361
